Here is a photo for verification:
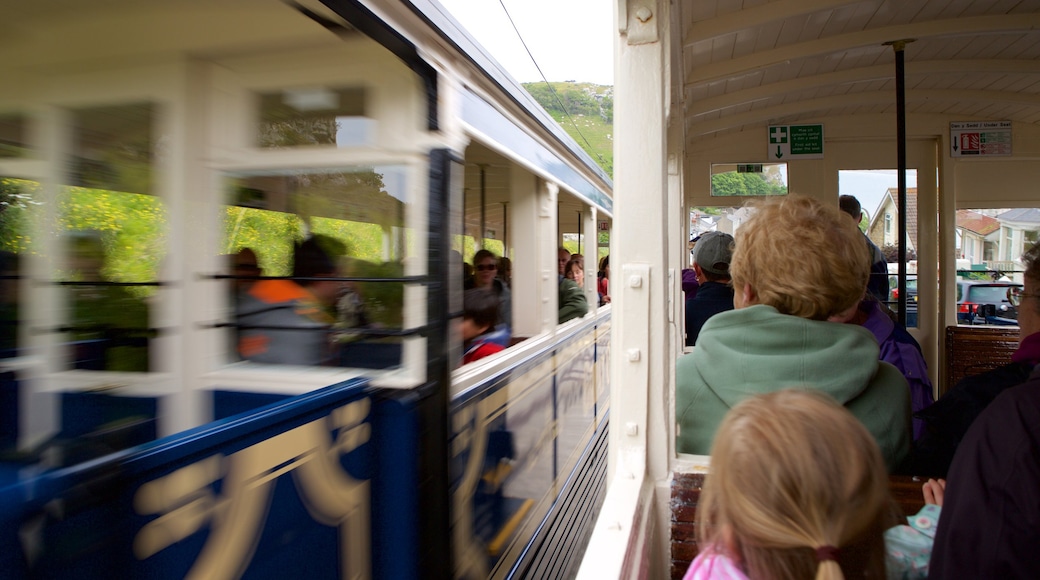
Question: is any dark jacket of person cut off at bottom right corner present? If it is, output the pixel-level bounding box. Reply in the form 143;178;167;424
929;370;1040;579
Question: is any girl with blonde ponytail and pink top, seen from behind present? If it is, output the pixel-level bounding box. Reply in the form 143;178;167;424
684;389;894;580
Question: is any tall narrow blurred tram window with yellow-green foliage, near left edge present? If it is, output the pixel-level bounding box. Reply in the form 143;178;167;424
53;104;161;372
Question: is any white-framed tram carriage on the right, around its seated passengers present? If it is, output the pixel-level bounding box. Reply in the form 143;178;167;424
579;0;1040;578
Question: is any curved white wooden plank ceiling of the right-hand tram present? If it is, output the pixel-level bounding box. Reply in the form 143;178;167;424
673;0;1040;141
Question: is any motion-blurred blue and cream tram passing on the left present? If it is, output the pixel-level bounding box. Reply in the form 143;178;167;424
0;0;614;579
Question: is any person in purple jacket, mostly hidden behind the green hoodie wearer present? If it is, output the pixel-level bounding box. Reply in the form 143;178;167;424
849;293;935;440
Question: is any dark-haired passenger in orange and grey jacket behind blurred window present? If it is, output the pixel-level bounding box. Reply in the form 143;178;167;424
237;236;341;365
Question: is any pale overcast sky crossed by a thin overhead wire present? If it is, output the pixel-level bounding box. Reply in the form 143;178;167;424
438;0;614;85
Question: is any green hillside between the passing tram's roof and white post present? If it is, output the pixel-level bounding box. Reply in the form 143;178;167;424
523;82;614;176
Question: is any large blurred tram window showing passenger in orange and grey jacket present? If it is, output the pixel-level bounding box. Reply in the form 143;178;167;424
222;165;409;368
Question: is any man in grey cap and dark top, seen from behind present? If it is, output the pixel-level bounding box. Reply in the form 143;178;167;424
686;232;733;346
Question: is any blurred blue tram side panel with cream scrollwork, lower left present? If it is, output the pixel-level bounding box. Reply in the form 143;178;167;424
0;380;417;580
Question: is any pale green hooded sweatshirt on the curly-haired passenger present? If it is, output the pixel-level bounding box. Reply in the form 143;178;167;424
675;305;910;471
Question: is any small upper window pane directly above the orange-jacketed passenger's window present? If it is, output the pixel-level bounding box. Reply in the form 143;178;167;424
258;86;375;148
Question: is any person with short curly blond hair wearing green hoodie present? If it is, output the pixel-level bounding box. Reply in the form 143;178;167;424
675;194;910;469
